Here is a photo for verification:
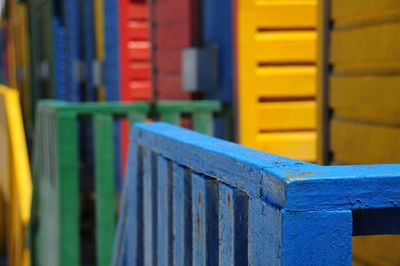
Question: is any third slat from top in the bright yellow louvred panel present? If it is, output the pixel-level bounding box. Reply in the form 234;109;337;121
254;66;316;98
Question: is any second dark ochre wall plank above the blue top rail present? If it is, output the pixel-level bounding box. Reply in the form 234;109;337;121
329;75;400;126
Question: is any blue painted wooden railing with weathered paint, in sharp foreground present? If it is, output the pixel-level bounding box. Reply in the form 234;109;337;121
113;123;400;265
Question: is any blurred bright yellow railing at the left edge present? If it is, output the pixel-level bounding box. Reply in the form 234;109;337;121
0;86;32;266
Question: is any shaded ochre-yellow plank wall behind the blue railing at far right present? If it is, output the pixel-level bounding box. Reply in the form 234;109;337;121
319;0;400;265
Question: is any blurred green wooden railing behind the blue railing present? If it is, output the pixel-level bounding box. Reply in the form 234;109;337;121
31;101;220;266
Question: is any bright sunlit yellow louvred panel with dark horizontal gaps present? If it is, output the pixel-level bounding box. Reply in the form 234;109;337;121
236;0;317;161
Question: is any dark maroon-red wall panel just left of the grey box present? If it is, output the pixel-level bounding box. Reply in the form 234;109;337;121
153;0;198;100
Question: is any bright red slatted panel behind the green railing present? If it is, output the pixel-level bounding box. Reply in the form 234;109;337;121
118;0;153;175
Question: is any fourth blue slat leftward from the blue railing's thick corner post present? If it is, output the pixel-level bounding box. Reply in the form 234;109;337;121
157;156;172;266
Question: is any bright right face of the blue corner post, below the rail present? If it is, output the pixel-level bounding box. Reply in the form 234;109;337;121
278;210;352;265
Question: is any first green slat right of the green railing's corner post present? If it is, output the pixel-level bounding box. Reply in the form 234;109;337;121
94;114;115;265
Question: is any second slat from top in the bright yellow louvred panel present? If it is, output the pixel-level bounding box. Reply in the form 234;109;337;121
255;31;317;64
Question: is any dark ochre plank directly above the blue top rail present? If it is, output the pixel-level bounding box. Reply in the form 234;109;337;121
330;120;400;164
